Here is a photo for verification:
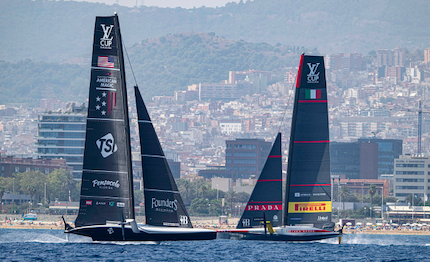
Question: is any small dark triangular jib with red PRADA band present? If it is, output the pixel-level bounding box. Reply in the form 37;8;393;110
237;133;282;228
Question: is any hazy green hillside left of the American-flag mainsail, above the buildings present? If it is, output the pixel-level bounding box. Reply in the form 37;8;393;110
0;60;90;106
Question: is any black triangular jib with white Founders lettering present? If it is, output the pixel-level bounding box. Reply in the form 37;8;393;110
135;87;193;228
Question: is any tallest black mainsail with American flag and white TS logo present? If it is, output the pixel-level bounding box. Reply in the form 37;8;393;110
75;15;134;227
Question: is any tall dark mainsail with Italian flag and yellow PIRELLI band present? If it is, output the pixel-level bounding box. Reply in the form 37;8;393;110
284;55;331;228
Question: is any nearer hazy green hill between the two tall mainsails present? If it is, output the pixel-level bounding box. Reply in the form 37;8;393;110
129;33;302;95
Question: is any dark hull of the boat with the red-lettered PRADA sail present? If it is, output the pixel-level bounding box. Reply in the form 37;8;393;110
217;232;342;242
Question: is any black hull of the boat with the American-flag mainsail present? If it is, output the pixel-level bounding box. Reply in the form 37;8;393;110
65;225;217;242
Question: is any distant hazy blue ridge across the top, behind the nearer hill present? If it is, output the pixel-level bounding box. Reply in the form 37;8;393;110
0;0;430;62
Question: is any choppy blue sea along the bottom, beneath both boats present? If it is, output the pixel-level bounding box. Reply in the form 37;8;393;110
0;229;430;262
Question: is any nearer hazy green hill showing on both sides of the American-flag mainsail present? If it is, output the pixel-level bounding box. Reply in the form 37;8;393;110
0;33;304;105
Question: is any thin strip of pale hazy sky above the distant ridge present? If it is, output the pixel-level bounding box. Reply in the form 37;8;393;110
69;0;239;8
